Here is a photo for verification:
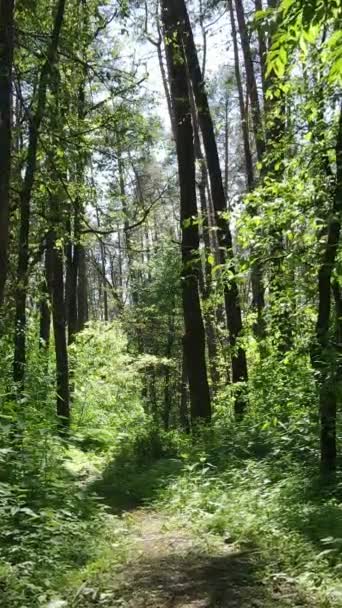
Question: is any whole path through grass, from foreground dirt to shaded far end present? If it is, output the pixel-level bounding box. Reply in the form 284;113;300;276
57;460;338;608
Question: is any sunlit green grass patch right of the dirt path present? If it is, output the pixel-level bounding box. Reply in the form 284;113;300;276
157;455;342;606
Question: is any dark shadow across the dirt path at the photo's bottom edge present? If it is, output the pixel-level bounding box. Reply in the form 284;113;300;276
95;550;308;608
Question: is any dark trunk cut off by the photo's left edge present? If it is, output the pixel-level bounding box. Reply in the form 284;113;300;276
0;0;14;308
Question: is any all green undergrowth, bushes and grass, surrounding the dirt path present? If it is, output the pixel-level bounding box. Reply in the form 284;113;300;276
0;326;342;608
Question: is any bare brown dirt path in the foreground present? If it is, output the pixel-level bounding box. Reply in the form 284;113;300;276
74;509;314;608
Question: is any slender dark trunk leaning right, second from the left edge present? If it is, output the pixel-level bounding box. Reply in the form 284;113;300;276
13;0;66;388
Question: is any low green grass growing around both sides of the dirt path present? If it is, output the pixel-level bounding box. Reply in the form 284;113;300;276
0;422;342;608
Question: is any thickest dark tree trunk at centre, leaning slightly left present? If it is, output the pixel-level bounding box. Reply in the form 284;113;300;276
162;0;211;422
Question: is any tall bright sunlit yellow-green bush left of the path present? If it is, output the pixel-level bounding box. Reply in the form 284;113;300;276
70;322;145;449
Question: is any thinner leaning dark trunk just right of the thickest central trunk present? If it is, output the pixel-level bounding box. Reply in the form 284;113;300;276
174;0;247;416
